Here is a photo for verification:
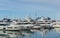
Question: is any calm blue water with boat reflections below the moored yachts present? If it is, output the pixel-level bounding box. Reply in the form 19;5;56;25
0;28;60;38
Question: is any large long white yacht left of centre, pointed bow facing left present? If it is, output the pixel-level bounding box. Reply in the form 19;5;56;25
6;18;34;30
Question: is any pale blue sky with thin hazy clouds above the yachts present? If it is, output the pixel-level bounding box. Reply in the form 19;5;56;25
0;0;60;19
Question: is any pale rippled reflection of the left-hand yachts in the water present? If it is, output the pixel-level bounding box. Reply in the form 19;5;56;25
0;31;33;38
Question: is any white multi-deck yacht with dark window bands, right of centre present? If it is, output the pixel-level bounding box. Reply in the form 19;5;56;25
36;17;52;26
